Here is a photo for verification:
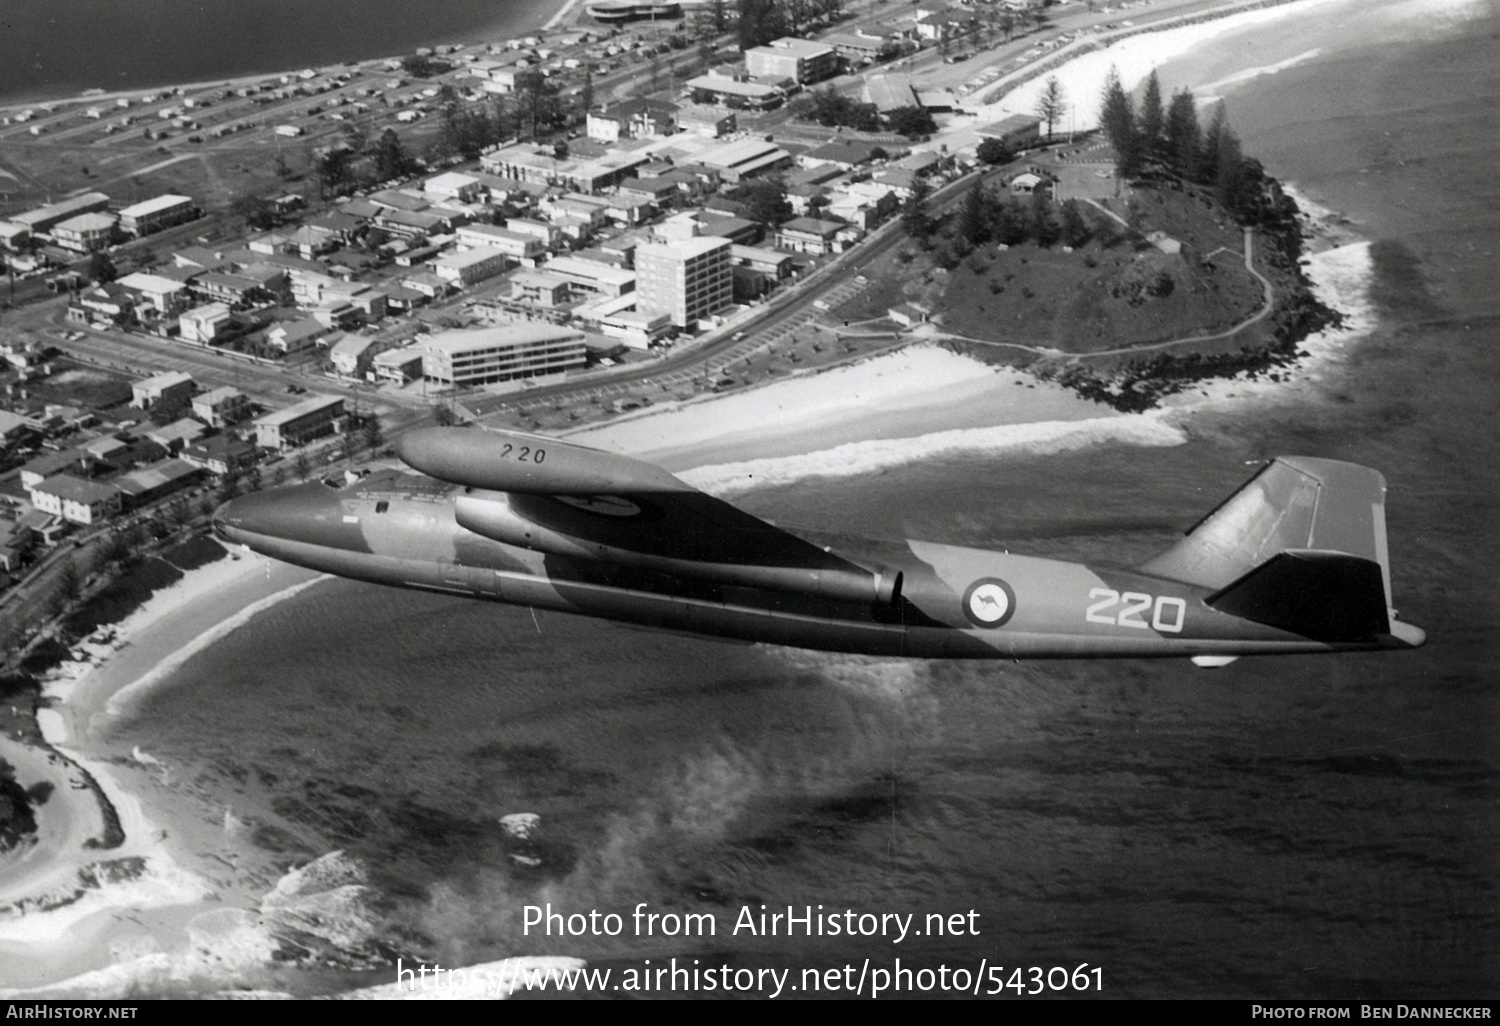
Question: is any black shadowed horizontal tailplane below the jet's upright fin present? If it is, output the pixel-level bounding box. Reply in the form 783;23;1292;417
1206;549;1391;642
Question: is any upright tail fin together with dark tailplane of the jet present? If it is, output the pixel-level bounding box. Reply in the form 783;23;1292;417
1137;456;1410;641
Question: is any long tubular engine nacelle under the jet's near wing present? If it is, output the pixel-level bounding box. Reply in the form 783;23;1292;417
455;492;902;605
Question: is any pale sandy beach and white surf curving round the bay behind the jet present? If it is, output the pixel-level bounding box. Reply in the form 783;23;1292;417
0;0;1416;993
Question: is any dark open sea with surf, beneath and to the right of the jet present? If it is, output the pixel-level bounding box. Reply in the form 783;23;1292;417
99;0;1500;999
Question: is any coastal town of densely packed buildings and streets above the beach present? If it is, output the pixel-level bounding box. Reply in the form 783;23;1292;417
0;0;1254;630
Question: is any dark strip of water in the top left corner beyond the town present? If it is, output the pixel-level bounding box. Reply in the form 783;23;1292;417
0;0;563;102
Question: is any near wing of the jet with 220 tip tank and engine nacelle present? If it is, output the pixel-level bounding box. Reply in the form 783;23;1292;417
396;428;902;603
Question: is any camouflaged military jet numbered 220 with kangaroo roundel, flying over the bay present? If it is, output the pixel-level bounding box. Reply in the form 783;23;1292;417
215;428;1425;666
